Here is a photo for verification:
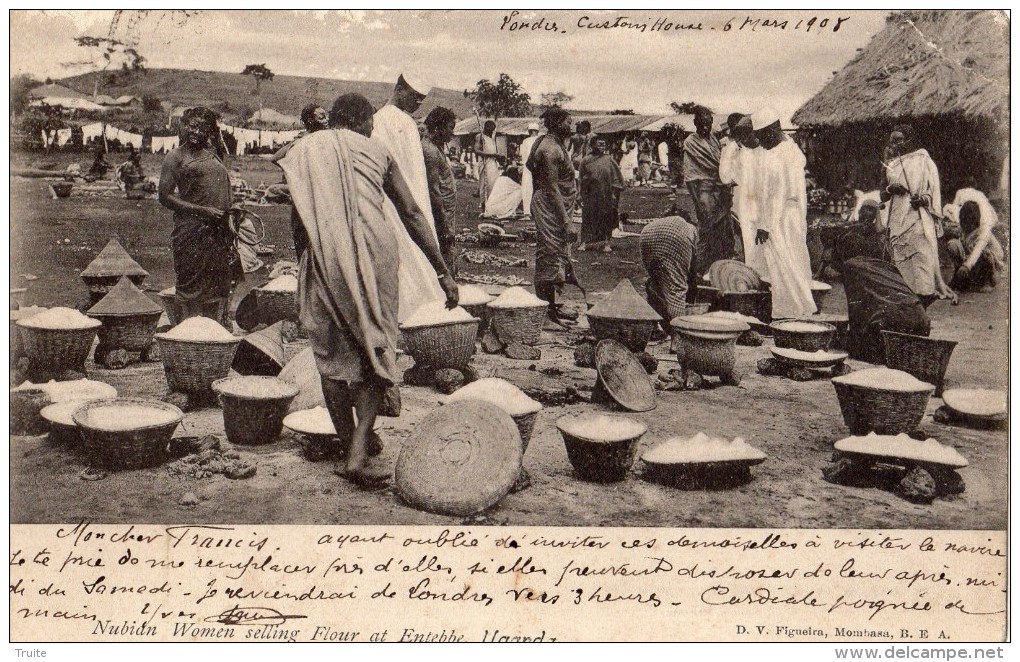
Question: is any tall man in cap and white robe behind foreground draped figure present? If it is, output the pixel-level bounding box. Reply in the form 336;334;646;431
371;74;443;321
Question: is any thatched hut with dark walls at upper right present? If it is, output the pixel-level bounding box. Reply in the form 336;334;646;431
793;10;1010;197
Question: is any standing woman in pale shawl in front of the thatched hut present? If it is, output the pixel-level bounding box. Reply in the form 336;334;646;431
882;124;956;305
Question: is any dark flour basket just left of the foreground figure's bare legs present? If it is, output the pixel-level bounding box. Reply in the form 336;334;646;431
212;377;298;446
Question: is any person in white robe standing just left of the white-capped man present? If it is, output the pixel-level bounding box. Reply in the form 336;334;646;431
719;115;765;275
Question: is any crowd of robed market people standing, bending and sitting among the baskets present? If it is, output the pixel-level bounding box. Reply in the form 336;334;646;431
153;75;1003;485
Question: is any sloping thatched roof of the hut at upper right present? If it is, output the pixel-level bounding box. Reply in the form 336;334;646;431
793;10;1010;126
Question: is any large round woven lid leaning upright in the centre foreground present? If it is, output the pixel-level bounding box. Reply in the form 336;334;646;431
395;400;523;516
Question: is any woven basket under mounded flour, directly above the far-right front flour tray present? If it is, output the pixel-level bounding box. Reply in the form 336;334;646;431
832;381;934;435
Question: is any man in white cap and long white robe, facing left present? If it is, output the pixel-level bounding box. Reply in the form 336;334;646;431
751;108;817;318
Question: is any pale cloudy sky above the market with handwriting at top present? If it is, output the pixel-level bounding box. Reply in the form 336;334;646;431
10;9;886;123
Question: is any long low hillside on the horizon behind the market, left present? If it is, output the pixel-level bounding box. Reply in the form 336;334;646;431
60;69;474;118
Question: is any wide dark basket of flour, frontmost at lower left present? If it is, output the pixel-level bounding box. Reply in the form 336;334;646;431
71;398;184;469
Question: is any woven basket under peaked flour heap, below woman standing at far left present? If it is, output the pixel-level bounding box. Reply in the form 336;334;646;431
156;334;243;399
